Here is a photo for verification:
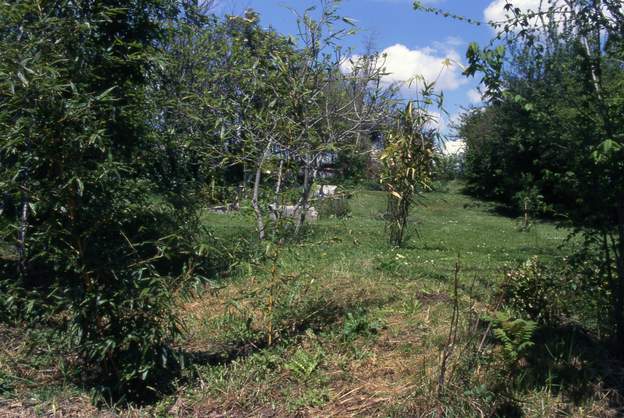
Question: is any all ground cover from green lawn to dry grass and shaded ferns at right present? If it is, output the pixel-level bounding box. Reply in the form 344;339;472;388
0;182;622;417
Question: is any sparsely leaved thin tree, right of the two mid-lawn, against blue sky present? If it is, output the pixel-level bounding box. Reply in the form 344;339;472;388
288;0;391;233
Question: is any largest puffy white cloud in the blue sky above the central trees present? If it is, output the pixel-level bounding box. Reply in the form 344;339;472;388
372;44;467;90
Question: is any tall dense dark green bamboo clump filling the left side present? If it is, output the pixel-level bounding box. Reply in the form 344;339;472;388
0;0;207;397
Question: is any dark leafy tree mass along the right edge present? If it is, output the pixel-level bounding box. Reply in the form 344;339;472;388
454;0;624;353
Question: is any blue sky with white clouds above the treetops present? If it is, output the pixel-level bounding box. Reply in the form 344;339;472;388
213;0;539;142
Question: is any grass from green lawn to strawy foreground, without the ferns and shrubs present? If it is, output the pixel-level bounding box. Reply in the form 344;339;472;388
0;183;612;417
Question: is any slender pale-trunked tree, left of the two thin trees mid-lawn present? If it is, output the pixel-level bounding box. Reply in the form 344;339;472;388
219;10;300;240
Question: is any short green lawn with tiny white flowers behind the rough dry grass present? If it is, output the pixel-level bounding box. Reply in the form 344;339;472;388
200;183;568;300
